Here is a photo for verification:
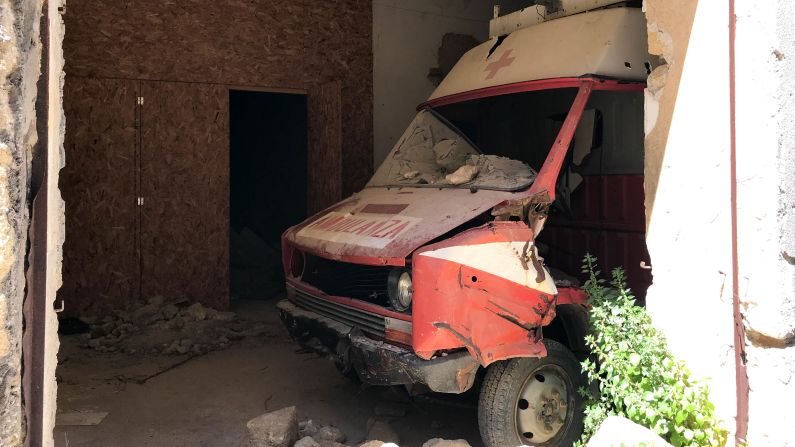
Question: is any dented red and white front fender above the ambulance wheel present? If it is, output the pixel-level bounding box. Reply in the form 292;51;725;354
412;222;557;366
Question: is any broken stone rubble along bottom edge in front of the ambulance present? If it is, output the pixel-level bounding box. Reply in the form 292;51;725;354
241;405;470;447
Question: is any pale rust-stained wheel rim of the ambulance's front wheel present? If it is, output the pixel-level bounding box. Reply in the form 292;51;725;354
516;365;570;444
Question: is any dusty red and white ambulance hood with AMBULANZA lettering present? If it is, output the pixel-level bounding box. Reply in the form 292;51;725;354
284;188;526;266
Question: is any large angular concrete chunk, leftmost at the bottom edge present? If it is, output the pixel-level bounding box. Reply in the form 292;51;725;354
240;407;298;447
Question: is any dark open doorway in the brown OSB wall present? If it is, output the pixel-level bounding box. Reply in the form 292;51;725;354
229;90;307;299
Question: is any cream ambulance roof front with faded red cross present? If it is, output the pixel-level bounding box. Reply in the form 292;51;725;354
429;7;656;100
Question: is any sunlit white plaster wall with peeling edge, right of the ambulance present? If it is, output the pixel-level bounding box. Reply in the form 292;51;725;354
644;0;795;446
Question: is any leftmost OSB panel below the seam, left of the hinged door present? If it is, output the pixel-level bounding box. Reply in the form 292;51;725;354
59;78;138;314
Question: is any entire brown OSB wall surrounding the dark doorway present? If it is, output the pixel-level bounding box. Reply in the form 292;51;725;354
61;0;373;312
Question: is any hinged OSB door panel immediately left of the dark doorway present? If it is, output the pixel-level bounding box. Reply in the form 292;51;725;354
141;81;229;308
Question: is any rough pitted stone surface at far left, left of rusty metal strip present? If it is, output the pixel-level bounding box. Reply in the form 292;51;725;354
0;0;41;447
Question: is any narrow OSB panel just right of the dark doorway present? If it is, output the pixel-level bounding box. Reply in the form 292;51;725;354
307;81;342;215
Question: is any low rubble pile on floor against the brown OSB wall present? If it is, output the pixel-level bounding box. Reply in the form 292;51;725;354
75;296;265;355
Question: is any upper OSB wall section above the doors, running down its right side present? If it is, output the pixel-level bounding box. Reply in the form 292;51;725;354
65;0;373;195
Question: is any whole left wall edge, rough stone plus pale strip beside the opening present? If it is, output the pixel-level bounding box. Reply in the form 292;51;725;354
0;0;64;447
